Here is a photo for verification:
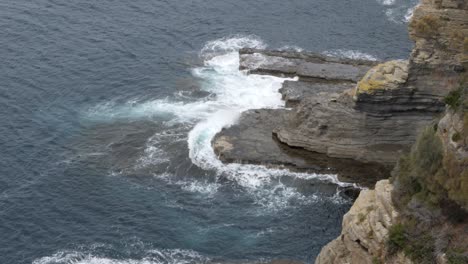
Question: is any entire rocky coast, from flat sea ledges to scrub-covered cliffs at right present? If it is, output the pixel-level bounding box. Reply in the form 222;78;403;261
212;0;468;264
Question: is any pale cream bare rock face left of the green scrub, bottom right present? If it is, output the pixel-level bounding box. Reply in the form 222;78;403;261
315;180;412;264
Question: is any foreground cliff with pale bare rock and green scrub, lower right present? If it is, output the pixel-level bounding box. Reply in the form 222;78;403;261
315;98;468;264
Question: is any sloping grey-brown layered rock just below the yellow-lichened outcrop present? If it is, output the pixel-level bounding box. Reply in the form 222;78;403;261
275;91;433;165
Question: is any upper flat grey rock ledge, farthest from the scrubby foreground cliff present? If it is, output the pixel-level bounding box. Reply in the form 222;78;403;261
239;49;378;107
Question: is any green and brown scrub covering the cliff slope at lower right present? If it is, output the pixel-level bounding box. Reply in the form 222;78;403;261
388;83;468;264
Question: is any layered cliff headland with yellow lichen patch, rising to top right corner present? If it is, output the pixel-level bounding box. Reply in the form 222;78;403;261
276;0;468;164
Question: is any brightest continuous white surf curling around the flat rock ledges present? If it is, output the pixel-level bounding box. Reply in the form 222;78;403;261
188;38;354;209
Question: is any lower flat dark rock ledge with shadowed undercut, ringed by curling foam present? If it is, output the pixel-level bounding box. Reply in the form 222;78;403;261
212;109;390;187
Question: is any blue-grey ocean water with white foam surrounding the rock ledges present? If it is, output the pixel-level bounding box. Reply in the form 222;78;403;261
0;0;417;264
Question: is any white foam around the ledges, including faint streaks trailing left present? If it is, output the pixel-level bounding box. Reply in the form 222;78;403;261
88;36;354;209
